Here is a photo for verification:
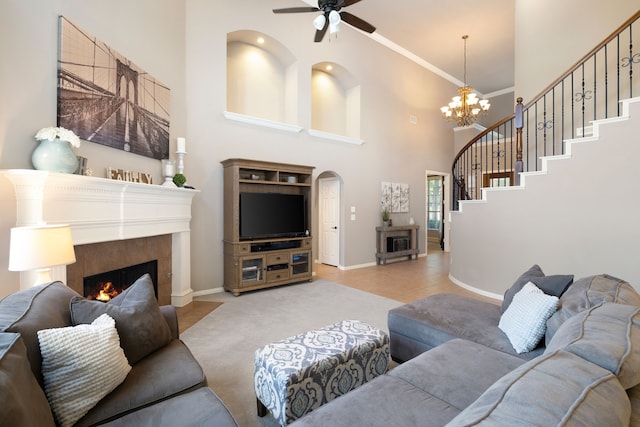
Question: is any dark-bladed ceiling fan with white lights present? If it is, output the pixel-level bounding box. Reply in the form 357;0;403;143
273;0;376;42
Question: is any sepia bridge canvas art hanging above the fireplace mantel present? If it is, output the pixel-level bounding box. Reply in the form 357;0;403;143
58;17;170;159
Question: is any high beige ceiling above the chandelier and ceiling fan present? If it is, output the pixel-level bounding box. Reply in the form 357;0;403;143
292;0;515;95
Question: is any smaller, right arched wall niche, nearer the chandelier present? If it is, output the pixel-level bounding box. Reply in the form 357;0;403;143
311;62;361;143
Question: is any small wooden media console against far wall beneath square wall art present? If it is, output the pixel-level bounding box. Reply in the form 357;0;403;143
376;225;420;265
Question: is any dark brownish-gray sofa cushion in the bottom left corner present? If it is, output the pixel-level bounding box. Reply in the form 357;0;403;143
0;333;55;427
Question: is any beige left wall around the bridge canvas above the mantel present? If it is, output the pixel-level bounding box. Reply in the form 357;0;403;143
0;0;186;296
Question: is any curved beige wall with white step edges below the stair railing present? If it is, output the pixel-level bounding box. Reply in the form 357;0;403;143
449;98;640;297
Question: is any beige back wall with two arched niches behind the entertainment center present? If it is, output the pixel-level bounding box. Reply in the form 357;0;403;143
186;0;455;289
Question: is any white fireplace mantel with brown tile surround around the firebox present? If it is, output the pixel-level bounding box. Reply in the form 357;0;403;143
2;170;198;307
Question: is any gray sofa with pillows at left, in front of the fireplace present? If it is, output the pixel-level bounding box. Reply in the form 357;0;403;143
0;276;237;427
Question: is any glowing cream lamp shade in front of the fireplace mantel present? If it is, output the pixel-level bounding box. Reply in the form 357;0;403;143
9;225;76;271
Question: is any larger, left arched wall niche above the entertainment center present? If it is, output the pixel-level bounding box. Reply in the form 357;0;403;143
227;30;298;124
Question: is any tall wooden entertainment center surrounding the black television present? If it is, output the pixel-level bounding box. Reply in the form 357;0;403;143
221;159;314;296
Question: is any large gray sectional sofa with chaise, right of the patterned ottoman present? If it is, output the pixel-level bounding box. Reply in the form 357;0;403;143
292;266;640;427
